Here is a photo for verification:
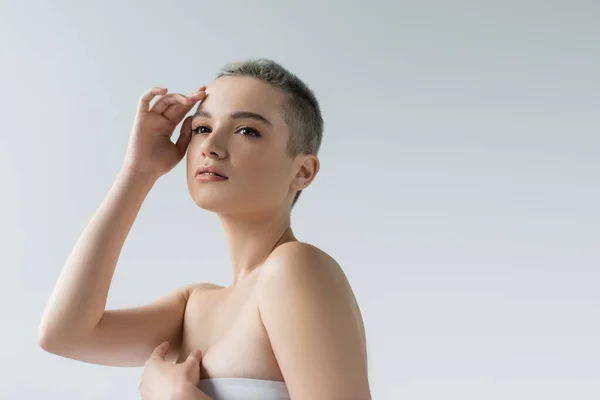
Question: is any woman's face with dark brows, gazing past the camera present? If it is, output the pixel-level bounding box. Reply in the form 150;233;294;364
187;77;299;214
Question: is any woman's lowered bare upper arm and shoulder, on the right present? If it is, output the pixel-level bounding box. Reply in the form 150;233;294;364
257;242;370;399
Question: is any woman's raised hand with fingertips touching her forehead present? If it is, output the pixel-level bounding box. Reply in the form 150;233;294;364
123;86;206;179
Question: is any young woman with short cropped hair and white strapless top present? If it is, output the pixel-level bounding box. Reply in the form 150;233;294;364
39;59;371;400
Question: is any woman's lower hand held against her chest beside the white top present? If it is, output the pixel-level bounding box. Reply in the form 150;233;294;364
139;342;208;400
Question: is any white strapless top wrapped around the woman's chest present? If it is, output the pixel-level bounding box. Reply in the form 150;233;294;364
198;378;290;400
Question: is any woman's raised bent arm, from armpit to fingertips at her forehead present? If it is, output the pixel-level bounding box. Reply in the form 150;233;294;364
38;87;211;366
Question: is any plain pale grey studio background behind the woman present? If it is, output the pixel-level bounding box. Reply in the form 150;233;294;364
0;0;600;400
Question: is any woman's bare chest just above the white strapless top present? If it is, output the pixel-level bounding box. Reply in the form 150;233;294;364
179;289;283;380
